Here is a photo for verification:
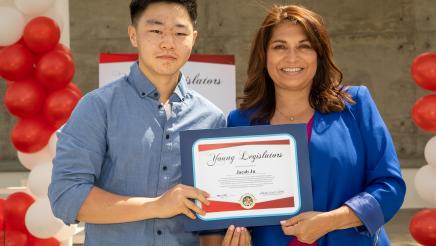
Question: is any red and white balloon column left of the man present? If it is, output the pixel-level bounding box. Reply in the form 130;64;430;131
0;0;82;246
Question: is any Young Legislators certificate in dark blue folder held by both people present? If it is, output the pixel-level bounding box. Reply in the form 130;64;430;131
180;124;312;231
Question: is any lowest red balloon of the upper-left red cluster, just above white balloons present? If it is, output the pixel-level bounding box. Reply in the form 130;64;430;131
11;118;54;153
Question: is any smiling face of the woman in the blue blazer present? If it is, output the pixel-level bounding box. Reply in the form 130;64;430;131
266;22;317;91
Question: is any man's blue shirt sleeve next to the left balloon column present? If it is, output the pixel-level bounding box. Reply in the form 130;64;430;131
48;92;107;224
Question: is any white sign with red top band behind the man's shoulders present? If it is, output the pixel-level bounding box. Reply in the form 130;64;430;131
99;54;236;115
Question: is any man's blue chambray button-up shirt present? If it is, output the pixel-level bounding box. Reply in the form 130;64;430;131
49;63;226;246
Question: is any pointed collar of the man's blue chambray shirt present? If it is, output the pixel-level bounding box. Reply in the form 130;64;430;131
128;62;188;101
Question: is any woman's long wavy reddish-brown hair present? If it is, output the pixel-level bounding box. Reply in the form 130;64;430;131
239;5;354;122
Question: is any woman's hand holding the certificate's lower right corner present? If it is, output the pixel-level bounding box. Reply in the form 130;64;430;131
280;211;333;244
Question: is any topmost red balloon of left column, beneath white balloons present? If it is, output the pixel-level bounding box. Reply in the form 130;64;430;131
23;16;61;53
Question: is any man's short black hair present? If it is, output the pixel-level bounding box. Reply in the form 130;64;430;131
130;0;197;25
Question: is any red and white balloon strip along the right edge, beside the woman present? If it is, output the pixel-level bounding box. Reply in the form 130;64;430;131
409;53;436;245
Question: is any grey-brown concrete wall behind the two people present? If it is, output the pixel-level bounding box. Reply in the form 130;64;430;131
0;0;436;170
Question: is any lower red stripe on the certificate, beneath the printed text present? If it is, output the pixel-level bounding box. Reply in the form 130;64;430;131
202;196;295;213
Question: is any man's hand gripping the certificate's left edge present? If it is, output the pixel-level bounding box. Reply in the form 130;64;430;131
156;184;209;219
